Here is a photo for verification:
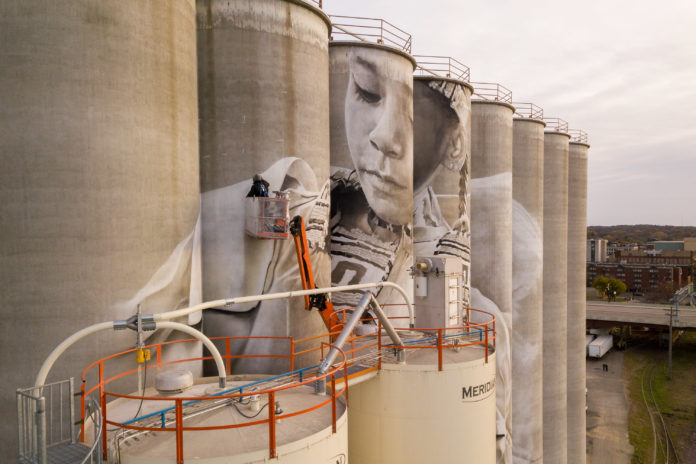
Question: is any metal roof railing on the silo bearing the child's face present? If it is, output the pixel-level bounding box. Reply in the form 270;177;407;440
329;15;413;53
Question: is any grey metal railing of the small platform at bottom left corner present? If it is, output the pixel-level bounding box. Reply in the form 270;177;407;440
17;378;76;463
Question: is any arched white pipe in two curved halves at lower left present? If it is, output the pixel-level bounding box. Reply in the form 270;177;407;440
34;322;227;387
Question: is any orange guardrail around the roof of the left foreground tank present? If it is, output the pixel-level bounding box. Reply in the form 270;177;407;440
80;334;348;464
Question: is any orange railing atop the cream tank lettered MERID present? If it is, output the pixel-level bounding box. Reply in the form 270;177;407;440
333;304;496;370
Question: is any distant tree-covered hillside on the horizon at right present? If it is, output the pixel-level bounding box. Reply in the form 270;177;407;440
587;224;696;244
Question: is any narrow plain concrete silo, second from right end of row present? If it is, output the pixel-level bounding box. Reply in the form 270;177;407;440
543;132;570;463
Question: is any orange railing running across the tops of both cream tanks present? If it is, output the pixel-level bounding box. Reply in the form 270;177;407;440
80;304;496;463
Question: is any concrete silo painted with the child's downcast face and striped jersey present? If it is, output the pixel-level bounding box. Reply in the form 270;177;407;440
329;42;415;323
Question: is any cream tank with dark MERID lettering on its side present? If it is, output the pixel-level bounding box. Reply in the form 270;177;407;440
348;352;497;464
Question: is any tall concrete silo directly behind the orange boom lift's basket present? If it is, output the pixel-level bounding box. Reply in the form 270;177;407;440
197;0;330;373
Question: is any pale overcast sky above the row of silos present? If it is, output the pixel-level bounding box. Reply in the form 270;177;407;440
324;0;696;226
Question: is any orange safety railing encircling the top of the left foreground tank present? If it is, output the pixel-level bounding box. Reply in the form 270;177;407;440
81;334;348;462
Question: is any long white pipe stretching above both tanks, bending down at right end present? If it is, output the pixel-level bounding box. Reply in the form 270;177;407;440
153;282;416;327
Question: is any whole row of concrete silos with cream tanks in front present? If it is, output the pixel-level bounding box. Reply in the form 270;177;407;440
0;0;589;464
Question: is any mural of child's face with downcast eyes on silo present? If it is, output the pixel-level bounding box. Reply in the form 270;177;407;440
345;48;413;224
